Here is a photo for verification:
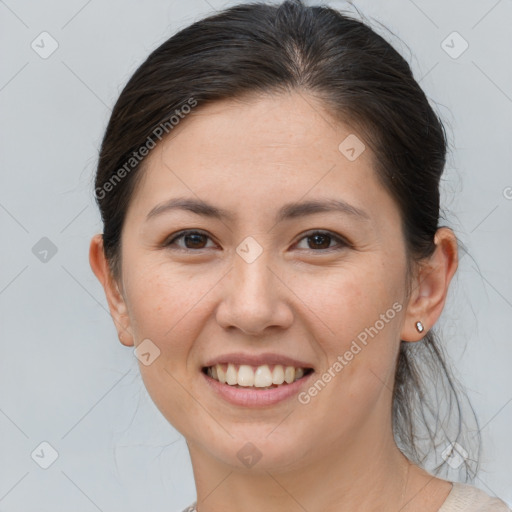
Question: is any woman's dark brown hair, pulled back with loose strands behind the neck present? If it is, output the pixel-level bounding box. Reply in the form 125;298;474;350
95;0;480;475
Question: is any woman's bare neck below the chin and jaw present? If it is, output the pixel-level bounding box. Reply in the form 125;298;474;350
188;420;418;512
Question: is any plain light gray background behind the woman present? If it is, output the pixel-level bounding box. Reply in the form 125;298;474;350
0;0;512;512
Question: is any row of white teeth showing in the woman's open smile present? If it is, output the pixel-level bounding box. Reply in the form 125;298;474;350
202;363;313;389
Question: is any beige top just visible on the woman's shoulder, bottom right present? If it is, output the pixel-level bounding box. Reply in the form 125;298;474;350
183;482;512;512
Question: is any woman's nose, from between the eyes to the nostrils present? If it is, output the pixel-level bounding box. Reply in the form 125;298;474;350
216;251;293;336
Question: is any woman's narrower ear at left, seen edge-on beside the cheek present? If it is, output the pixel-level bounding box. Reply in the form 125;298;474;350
89;234;134;347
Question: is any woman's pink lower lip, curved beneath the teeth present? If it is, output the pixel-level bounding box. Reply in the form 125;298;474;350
201;372;314;407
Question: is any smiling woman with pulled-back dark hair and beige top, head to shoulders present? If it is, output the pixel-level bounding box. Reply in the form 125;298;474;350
90;1;508;512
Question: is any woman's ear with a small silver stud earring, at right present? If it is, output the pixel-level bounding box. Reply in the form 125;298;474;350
400;227;458;341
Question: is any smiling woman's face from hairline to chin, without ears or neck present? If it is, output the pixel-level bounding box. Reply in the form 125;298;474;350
101;93;416;470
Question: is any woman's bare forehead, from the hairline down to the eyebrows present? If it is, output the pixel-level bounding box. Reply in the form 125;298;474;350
125;93;400;229
